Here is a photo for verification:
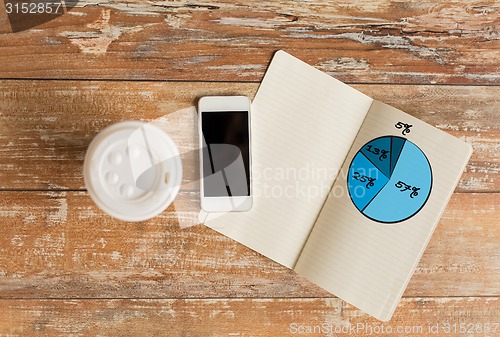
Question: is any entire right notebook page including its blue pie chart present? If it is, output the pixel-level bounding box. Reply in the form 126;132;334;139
295;101;471;320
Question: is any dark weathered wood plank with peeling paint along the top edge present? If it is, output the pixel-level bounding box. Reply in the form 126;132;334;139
0;0;500;84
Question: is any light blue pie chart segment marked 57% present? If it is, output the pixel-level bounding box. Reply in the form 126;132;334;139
363;141;432;223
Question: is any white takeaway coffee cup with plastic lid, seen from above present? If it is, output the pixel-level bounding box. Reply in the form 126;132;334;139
83;121;182;221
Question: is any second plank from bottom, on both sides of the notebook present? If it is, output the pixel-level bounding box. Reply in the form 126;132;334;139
0;191;500;298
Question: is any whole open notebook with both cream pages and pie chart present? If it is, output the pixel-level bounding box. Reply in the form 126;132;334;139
201;51;471;320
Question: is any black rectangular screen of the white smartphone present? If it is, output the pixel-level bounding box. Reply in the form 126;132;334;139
201;111;250;197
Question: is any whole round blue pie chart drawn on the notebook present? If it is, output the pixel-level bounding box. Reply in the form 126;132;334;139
347;136;432;224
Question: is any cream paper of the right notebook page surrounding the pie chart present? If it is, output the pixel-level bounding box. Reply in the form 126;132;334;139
295;101;471;320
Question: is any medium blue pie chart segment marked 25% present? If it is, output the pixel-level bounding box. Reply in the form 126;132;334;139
348;152;389;210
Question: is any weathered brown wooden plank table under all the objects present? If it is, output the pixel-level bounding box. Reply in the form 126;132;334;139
0;0;500;336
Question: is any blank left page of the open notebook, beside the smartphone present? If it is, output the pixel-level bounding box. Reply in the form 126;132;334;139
201;51;373;268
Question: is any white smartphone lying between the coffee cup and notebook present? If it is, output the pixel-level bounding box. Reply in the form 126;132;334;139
198;96;253;212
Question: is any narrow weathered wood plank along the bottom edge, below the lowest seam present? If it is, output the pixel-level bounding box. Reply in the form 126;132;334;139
0;297;500;337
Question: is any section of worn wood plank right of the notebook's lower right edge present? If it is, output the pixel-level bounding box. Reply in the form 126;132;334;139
406;193;500;296
